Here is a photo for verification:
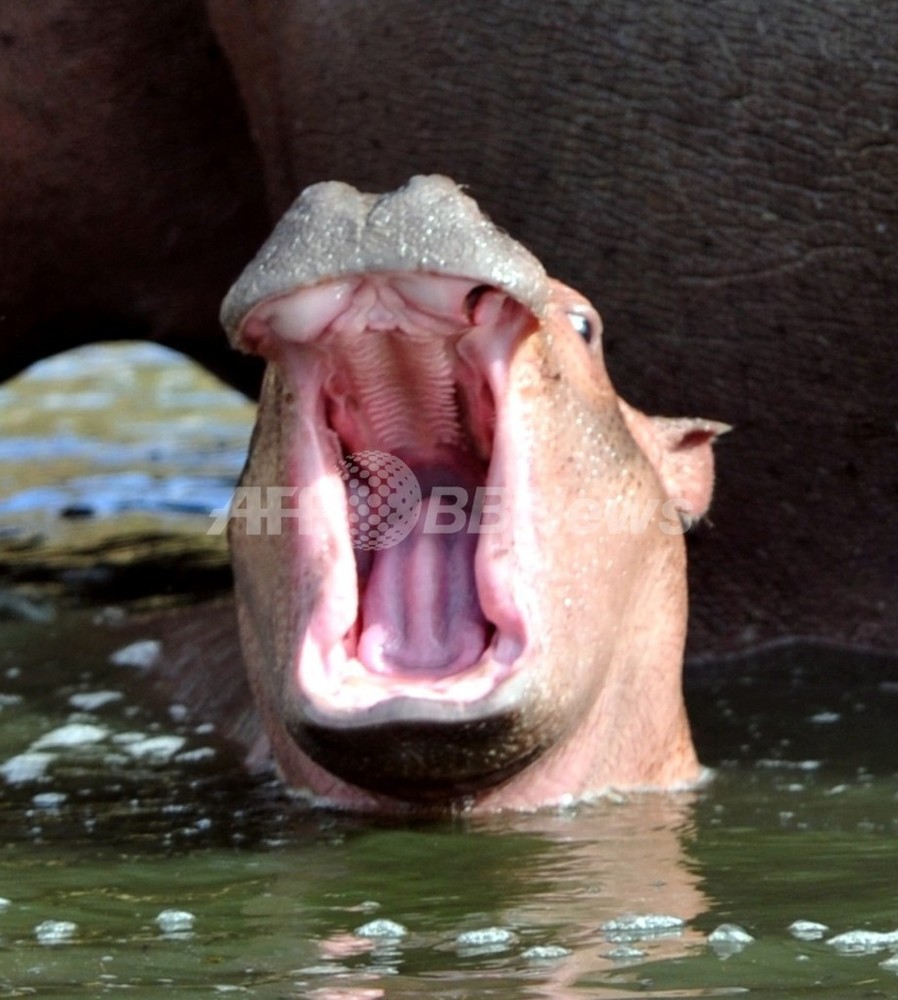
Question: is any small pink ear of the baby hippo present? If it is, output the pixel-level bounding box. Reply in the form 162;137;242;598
648;417;732;527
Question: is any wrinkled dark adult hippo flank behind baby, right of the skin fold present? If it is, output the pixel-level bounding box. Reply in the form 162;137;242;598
209;0;898;653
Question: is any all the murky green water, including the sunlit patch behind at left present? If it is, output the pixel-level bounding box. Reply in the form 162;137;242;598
0;342;898;1000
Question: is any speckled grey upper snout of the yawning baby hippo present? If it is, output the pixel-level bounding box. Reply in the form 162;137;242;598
221;176;548;342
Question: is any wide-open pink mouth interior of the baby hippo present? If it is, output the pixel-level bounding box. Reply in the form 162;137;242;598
243;272;536;721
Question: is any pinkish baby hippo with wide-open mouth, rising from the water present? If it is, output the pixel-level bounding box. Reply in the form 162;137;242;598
222;176;726;811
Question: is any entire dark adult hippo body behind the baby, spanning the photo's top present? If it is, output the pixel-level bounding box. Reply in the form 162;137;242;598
0;9;898;688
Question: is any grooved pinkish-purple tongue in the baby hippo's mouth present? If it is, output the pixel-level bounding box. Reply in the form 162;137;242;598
357;497;490;677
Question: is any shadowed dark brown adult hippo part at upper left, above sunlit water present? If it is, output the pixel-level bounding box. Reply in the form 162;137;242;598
0;0;268;392
